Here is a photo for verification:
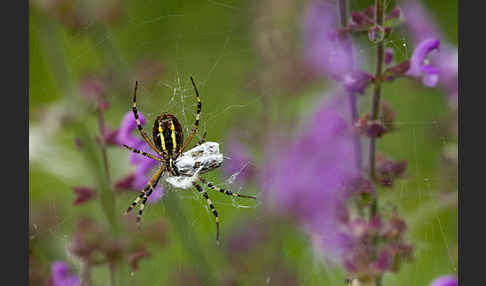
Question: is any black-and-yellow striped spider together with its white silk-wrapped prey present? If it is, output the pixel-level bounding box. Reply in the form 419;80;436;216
123;77;256;243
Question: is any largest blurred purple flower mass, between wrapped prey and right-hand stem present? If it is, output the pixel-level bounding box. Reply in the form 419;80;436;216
262;94;359;258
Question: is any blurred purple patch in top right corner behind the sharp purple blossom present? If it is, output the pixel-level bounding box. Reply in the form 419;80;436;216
402;0;458;106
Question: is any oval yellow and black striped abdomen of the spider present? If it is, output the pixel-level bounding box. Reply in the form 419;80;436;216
153;113;184;158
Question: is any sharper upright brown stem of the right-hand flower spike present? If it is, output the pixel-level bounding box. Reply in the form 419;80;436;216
369;0;385;217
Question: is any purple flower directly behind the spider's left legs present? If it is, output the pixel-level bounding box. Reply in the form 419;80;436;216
116;111;163;203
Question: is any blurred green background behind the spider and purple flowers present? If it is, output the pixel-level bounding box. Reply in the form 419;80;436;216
29;0;457;286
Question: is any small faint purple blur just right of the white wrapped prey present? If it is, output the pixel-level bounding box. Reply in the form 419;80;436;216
223;135;254;184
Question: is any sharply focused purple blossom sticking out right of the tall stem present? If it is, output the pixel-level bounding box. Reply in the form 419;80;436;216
406;39;440;87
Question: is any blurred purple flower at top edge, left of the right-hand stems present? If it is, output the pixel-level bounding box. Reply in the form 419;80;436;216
303;1;353;80
